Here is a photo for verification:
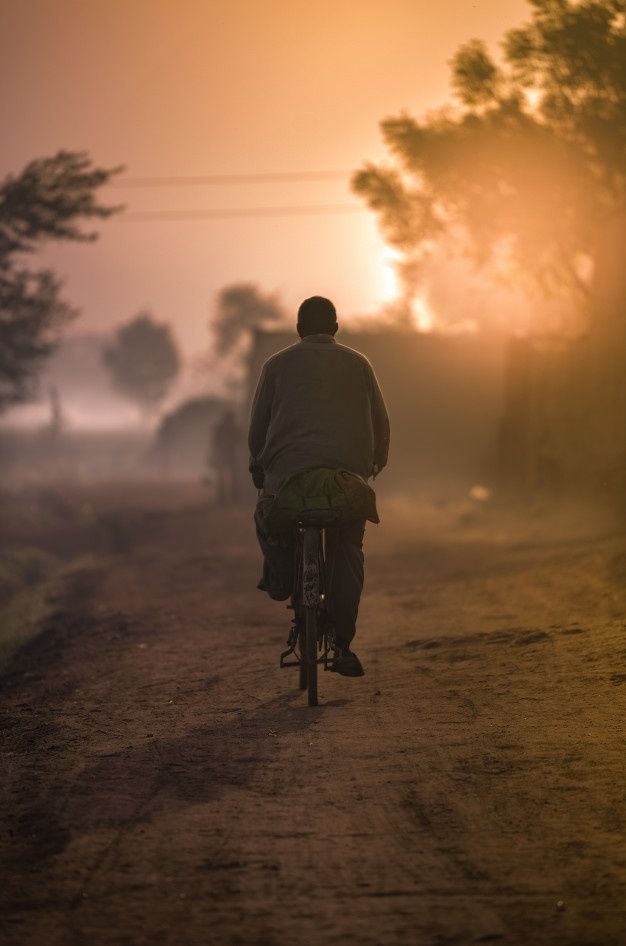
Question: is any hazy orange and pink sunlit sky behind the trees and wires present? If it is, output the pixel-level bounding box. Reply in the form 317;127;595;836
0;0;527;353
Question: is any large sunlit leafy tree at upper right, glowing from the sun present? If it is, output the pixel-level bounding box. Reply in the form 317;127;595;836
352;0;626;337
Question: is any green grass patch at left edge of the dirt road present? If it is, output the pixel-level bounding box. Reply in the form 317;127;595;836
0;547;102;673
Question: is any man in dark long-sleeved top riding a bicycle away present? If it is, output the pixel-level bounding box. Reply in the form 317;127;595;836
248;296;389;676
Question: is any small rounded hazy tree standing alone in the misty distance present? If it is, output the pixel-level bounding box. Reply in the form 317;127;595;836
103;312;180;416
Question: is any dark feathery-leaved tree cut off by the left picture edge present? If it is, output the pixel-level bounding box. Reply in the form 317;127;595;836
0;151;121;411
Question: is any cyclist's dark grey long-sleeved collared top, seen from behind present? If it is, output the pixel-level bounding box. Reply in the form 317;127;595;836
248;335;389;494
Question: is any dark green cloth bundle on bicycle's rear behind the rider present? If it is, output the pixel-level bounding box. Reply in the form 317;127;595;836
264;467;380;536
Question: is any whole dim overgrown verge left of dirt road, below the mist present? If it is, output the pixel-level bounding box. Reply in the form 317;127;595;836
0;481;187;674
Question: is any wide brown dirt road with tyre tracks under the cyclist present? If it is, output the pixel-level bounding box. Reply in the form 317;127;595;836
0;486;626;946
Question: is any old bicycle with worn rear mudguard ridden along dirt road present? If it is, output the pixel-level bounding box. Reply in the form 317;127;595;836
280;518;335;706
